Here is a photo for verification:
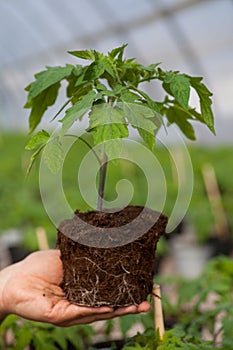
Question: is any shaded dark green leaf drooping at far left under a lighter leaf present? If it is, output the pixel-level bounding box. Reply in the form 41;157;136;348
26;83;60;133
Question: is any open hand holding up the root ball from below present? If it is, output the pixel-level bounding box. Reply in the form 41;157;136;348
0;249;150;327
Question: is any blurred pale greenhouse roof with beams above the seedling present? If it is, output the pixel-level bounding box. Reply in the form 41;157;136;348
0;0;233;142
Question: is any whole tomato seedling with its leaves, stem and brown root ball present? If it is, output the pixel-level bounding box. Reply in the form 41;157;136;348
25;45;214;307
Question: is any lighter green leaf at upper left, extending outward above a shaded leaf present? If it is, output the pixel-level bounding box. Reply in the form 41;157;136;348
26;65;74;102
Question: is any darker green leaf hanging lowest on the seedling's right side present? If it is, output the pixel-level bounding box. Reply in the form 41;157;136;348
166;106;196;140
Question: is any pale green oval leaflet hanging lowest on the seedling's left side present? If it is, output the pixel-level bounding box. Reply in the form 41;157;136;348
43;137;64;174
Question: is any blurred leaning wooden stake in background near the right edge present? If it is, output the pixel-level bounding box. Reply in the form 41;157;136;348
202;164;229;239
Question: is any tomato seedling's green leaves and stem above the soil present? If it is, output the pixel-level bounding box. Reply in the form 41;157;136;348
25;45;215;211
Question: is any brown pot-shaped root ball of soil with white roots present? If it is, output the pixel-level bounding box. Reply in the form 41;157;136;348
58;206;167;307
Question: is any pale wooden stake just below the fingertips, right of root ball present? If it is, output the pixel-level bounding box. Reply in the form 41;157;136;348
152;284;165;339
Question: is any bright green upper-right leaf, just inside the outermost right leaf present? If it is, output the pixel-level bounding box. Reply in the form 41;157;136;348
164;72;190;109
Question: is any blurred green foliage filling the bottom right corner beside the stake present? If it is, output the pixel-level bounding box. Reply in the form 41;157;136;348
154;256;233;350
